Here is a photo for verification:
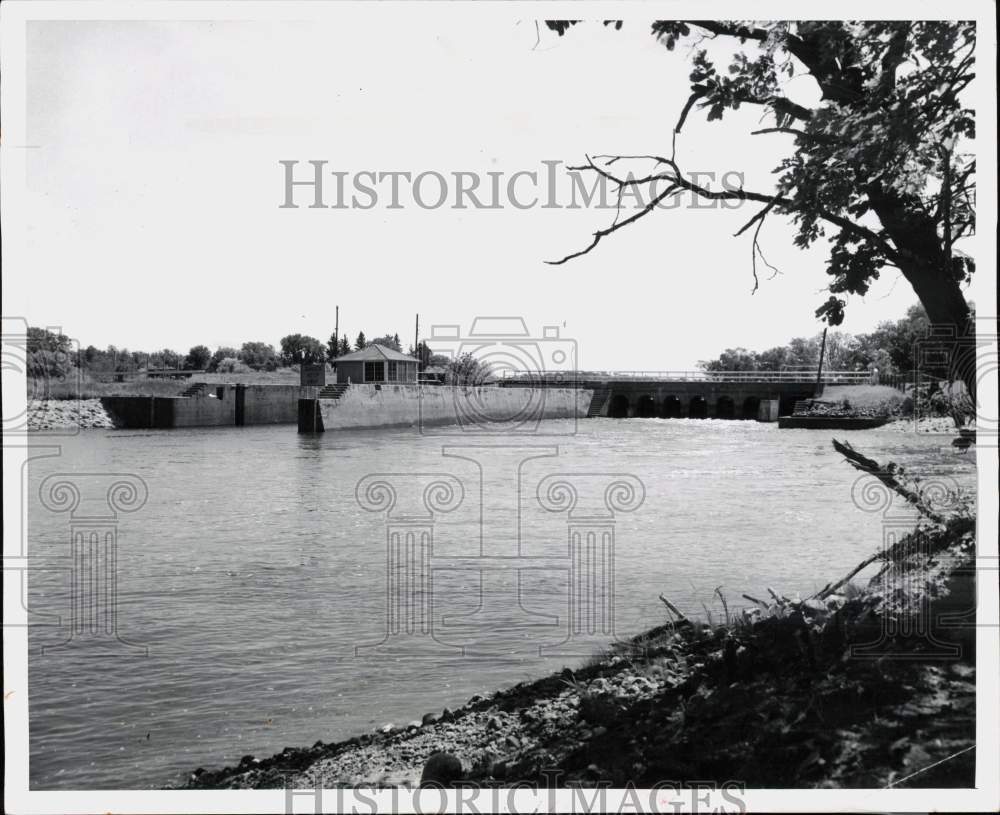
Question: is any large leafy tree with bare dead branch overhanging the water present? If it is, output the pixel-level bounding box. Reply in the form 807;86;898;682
547;20;976;397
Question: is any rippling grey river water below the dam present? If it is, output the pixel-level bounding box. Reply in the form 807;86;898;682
28;419;975;789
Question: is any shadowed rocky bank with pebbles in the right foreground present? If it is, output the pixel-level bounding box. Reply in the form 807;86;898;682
179;506;975;789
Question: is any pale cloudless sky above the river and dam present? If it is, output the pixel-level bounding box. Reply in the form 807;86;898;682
15;17;976;370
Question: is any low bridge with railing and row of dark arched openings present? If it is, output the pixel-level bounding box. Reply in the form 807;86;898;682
498;369;873;421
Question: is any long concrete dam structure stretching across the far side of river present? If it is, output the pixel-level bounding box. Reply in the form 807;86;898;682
101;371;870;433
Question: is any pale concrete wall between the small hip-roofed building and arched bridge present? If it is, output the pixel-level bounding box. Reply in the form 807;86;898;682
299;385;593;433
